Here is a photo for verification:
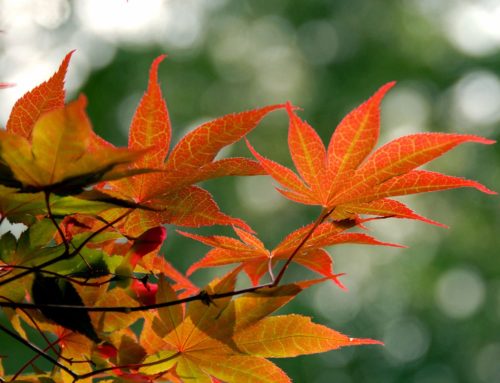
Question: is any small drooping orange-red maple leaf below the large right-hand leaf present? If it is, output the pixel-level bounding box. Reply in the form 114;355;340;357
178;221;401;286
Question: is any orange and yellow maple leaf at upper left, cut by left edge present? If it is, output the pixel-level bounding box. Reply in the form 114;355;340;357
0;52;153;194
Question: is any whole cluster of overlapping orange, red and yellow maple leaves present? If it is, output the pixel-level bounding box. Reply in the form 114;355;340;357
0;53;493;383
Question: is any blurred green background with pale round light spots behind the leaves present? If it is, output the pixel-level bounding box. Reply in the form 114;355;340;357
0;0;500;383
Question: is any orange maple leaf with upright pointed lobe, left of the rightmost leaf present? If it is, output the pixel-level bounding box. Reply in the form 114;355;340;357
95;55;284;235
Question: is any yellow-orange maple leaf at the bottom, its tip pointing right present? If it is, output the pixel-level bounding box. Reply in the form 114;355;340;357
139;270;380;383
